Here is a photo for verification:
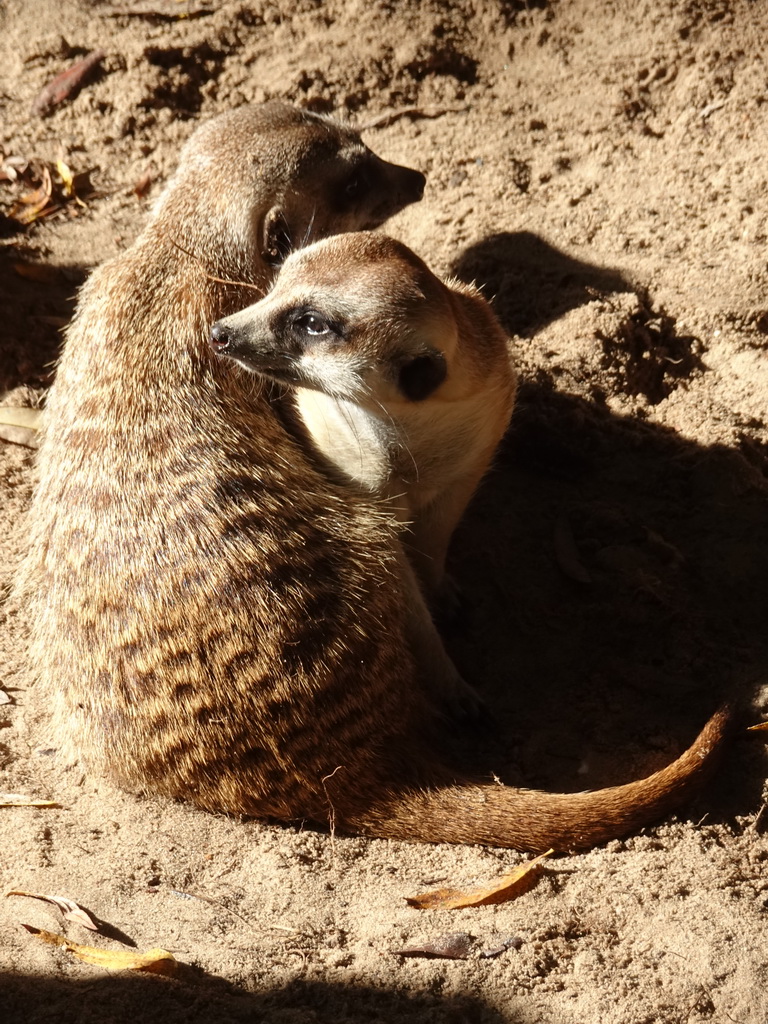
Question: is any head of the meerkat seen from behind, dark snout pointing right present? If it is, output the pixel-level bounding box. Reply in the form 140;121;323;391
161;101;426;276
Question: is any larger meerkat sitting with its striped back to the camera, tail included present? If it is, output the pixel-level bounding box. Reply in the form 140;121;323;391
22;103;727;850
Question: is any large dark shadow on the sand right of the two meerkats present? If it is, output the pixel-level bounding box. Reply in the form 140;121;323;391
445;233;768;816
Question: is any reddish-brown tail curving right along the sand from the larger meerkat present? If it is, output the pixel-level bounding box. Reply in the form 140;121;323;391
346;707;731;853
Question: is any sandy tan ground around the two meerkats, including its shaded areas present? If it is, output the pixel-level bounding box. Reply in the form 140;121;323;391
0;0;768;1024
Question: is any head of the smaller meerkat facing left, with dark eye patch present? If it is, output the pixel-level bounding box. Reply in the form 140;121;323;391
211;231;457;407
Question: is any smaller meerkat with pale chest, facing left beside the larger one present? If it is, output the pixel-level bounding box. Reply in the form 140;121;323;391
211;231;516;602
